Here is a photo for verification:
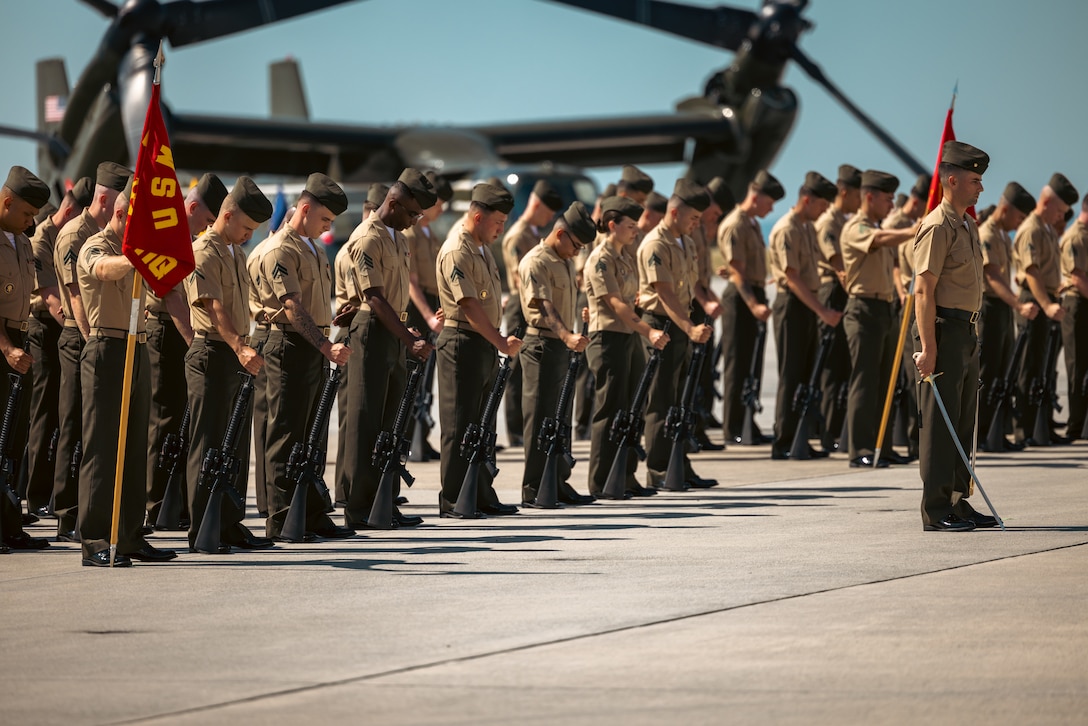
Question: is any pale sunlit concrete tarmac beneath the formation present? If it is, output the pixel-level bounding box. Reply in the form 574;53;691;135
0;426;1088;725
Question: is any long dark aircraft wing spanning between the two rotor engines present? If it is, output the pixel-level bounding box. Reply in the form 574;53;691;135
165;110;740;182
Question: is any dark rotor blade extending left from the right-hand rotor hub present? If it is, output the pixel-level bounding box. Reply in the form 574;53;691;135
552;0;757;51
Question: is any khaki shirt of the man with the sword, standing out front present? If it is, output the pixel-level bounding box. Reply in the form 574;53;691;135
907;199;982;312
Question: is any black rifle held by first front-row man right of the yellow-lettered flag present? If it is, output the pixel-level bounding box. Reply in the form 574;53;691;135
194;341;264;554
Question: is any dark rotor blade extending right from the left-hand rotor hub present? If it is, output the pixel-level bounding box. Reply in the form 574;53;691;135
161;0;365;48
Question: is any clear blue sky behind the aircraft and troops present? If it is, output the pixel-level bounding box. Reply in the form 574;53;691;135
0;0;1088;206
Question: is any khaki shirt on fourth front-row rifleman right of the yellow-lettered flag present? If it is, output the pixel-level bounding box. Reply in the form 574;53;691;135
435;225;503;329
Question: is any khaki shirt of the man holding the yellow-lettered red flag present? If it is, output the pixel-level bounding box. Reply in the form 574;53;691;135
76;226;147;333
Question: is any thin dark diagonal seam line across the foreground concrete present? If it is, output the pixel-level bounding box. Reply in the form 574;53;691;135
107;542;1088;726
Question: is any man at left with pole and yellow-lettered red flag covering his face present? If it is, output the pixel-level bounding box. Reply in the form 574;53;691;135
77;49;194;567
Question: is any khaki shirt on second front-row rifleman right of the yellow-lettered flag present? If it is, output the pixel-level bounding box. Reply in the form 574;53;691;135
257;224;333;328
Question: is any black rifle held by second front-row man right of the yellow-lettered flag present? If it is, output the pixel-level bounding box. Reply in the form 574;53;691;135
280;361;337;542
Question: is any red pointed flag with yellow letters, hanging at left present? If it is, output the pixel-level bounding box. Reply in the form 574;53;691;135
122;84;196;297
